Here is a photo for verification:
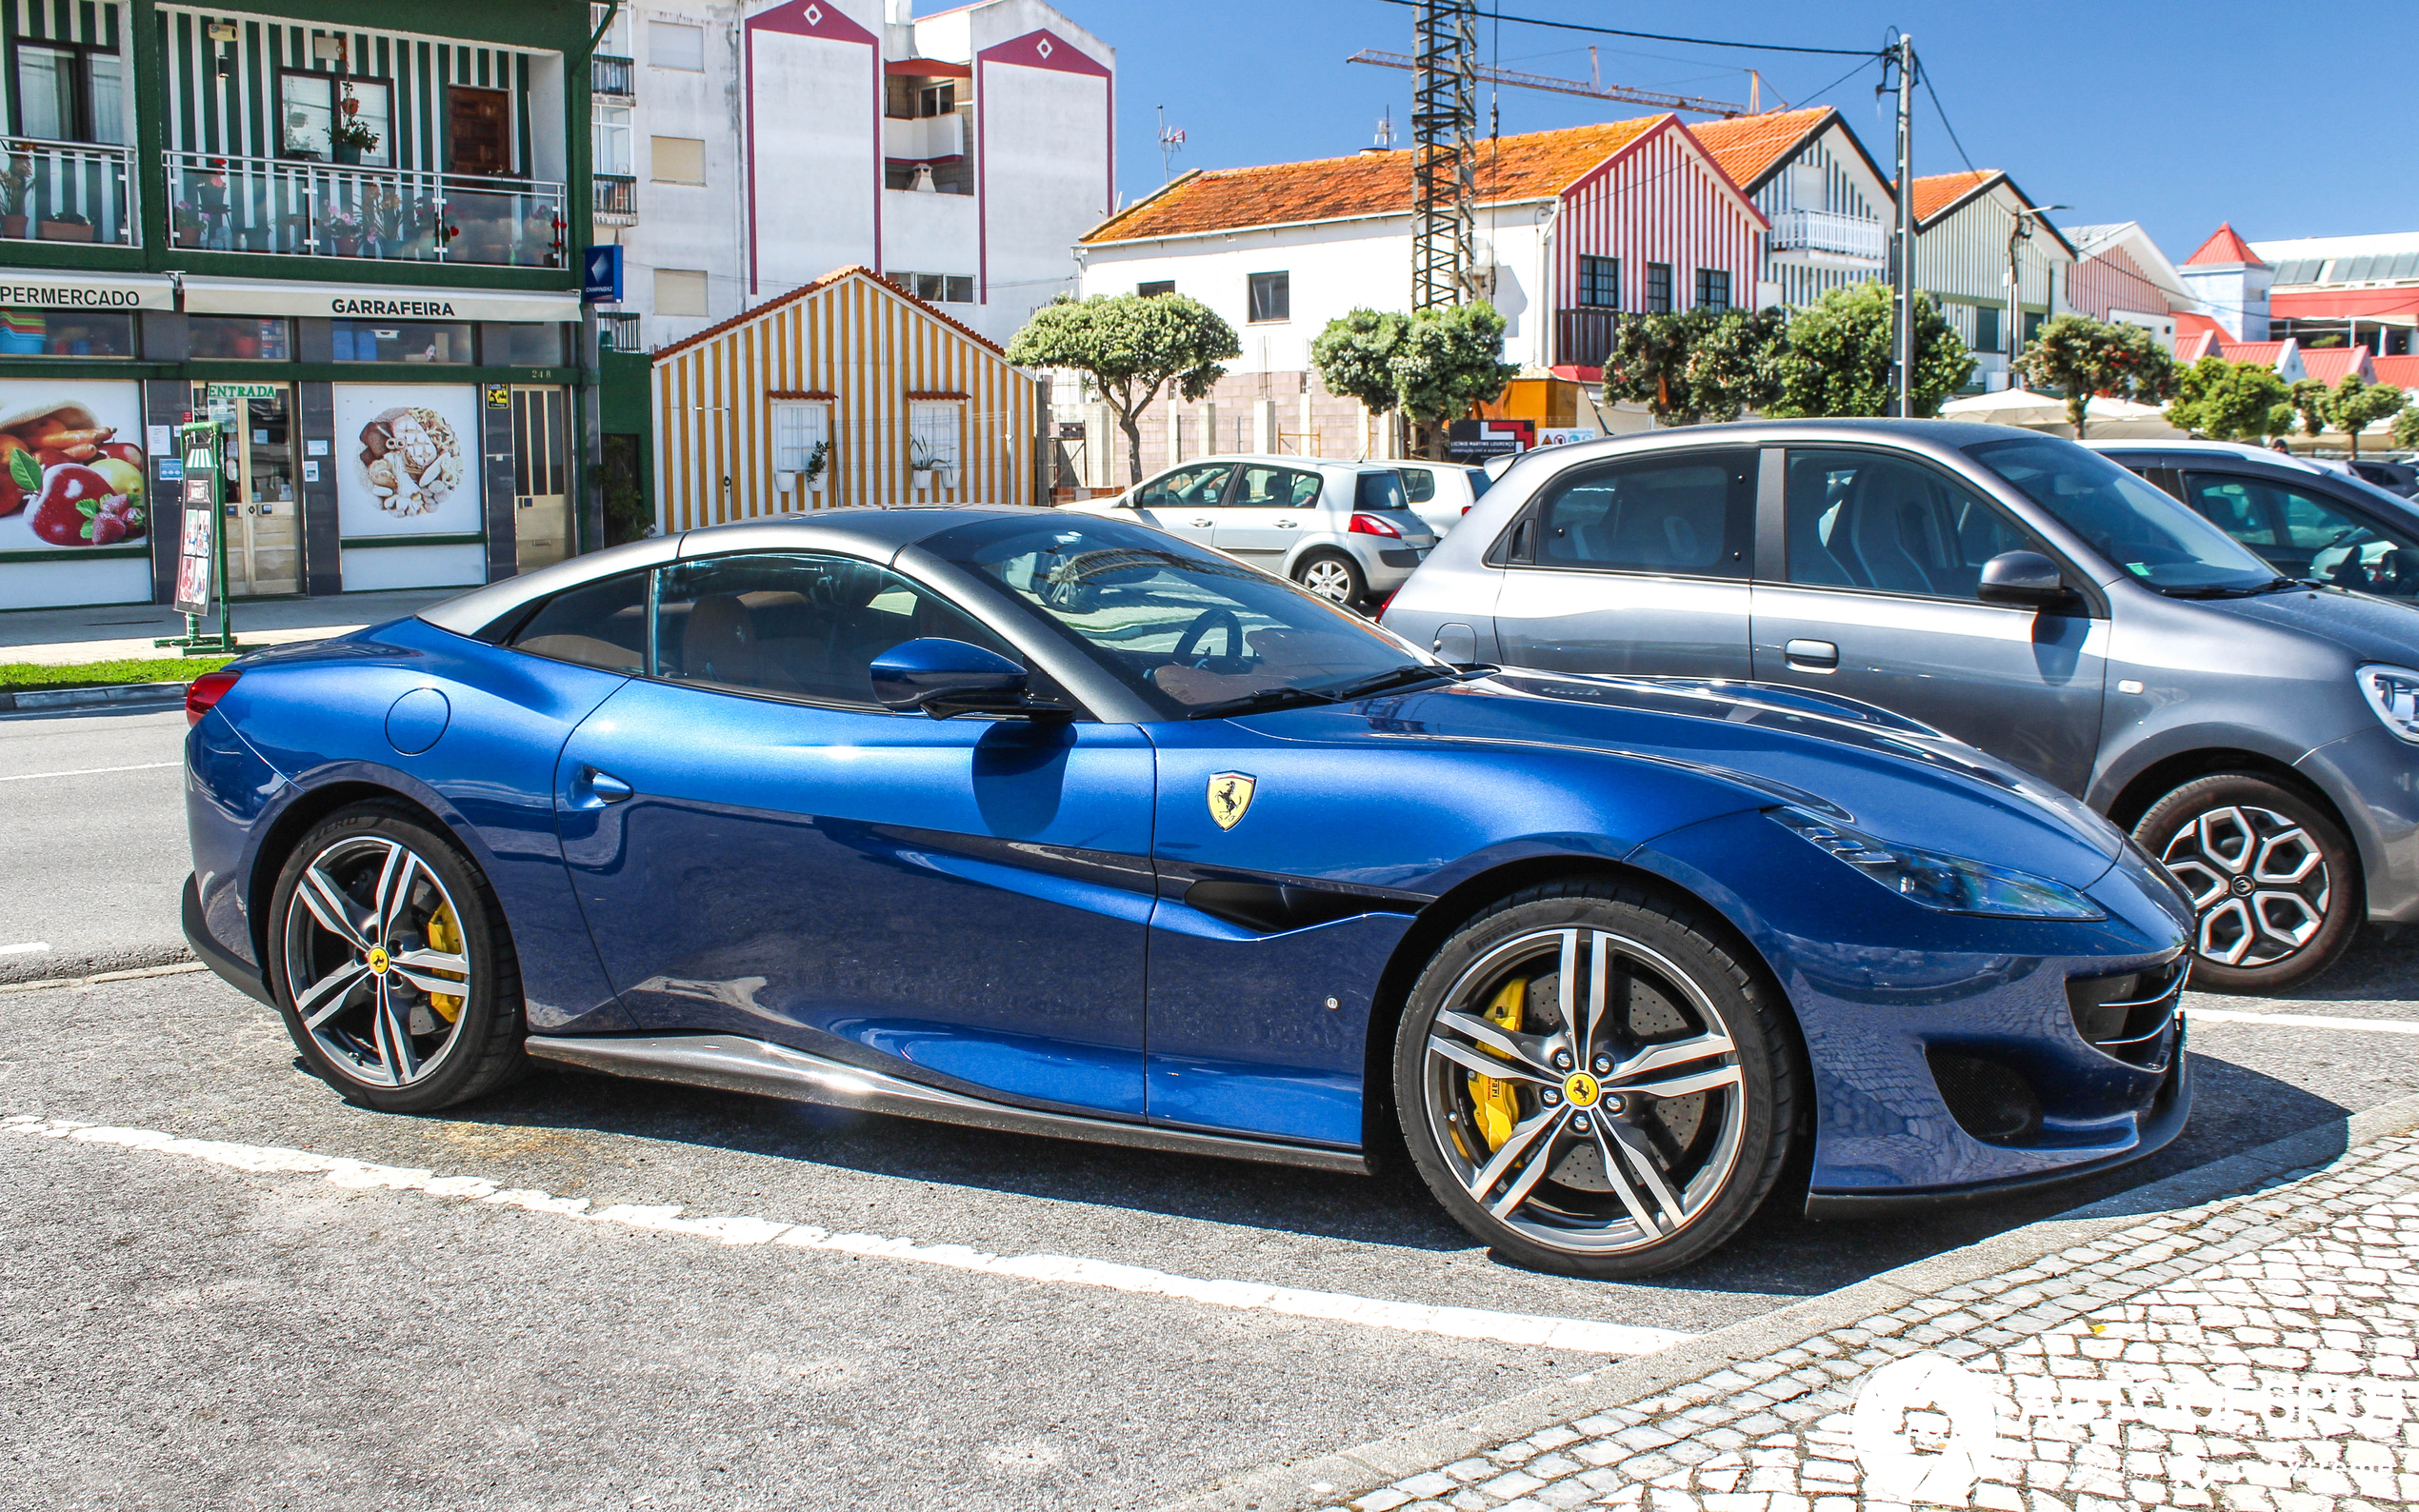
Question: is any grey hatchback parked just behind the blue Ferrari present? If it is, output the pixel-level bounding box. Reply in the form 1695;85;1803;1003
1386;421;2419;992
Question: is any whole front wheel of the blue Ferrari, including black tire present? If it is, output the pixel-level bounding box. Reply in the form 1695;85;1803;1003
1393;881;1805;1280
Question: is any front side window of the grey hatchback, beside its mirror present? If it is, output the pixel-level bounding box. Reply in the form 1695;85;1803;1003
1783;450;2042;598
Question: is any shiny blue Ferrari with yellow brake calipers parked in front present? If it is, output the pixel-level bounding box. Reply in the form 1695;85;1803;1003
184;508;2191;1275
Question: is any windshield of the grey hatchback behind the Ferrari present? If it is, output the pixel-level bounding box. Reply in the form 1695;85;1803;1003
1967;435;2279;598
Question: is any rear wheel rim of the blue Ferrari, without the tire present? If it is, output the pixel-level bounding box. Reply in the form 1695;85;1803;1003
286;835;471;1086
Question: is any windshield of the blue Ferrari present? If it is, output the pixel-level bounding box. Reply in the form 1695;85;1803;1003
924;512;1454;719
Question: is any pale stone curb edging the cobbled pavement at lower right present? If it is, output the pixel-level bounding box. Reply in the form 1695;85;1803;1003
1156;1093;2419;1512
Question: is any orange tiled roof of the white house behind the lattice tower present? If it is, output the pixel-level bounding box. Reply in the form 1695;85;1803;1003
1084;116;1679;242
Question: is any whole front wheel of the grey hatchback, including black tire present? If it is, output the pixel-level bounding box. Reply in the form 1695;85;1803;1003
2133;772;2369;994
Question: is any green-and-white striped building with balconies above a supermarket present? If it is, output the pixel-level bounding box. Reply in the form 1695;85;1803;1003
0;0;612;609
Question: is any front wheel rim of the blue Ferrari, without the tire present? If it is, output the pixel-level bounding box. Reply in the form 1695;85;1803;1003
1423;929;1747;1256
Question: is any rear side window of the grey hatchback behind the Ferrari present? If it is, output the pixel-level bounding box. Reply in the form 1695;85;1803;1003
1533;450;1756;578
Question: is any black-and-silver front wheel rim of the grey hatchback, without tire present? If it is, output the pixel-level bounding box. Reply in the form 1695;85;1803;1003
2160;804;2334;967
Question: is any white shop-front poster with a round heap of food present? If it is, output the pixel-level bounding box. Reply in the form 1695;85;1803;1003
336;382;479;537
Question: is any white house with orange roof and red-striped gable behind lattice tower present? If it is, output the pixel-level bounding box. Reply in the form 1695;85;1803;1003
1076;116;1769;477
